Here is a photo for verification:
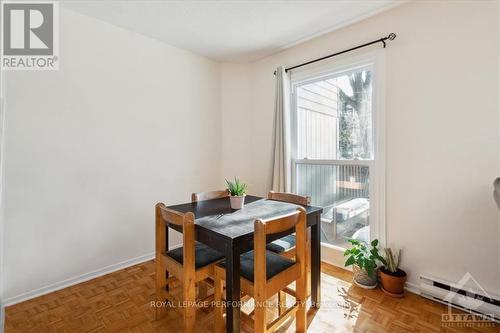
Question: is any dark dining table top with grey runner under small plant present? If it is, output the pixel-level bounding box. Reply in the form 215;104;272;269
168;195;322;239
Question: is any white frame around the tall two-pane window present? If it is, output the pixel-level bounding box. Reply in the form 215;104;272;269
290;50;386;249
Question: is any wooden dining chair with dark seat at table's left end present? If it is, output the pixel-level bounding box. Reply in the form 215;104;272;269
156;203;224;333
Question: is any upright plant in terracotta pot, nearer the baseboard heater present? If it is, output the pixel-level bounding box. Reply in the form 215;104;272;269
380;248;406;297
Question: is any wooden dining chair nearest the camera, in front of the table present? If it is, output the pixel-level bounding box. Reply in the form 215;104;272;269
215;207;306;333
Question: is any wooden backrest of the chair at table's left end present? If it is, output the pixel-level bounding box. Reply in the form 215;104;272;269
156;203;195;270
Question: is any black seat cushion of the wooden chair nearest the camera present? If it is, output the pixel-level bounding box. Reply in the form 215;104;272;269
218;251;295;282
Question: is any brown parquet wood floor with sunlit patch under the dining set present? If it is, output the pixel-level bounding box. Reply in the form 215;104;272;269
5;261;500;333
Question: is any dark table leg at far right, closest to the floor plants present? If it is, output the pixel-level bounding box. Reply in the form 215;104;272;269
311;214;321;308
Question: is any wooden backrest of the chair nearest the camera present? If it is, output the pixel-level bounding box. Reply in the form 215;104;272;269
254;207;306;295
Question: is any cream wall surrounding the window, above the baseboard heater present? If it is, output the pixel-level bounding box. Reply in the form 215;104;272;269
222;1;500;294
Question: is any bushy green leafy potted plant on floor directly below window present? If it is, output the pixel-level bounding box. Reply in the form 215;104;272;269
344;239;383;289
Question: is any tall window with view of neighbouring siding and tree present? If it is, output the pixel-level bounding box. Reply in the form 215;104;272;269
292;55;383;252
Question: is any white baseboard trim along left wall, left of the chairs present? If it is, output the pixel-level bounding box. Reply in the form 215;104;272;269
0;252;155;306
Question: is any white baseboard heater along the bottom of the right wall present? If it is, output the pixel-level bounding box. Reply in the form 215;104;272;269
420;274;500;323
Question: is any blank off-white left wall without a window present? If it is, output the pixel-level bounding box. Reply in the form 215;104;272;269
1;8;221;302
